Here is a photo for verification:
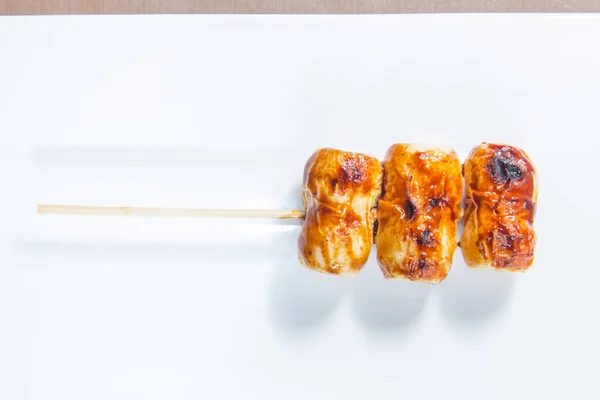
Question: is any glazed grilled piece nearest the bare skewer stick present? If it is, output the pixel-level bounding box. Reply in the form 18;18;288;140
298;149;383;275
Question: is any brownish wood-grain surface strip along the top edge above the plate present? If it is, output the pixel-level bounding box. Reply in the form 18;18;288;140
0;0;600;15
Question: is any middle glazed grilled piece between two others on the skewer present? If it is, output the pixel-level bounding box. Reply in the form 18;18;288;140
375;144;462;283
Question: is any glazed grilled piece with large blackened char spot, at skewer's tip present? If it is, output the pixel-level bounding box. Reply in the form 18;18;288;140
460;143;538;271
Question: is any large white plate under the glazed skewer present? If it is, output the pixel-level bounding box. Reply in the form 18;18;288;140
0;15;600;400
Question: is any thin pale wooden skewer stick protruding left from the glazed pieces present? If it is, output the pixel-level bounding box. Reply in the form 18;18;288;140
37;204;305;219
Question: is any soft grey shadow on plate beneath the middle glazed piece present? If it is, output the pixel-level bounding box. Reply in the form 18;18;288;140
353;261;432;335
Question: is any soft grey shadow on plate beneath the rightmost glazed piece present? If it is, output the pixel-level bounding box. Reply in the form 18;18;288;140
439;260;516;327
